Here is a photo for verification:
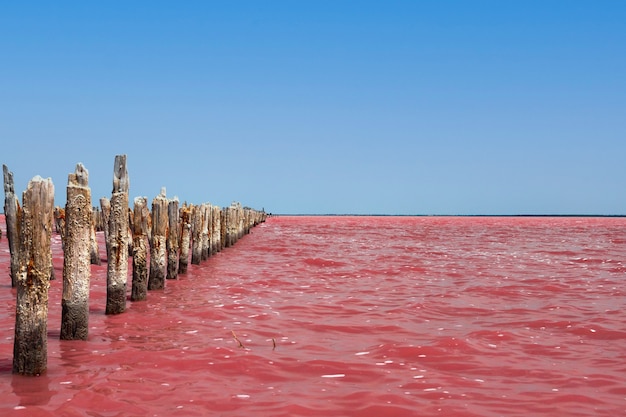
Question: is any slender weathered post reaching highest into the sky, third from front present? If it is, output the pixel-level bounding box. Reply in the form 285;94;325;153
101;155;129;314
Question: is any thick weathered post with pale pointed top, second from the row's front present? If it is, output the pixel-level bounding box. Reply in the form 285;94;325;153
61;163;93;340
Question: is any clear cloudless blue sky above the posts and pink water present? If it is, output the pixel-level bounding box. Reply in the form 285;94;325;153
0;0;626;214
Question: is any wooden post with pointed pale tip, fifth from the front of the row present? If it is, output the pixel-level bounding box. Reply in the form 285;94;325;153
148;188;168;290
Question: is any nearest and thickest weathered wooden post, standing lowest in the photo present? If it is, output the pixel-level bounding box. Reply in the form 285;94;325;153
13;176;54;375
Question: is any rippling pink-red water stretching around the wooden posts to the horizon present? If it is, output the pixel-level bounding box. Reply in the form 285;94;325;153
0;217;626;417
